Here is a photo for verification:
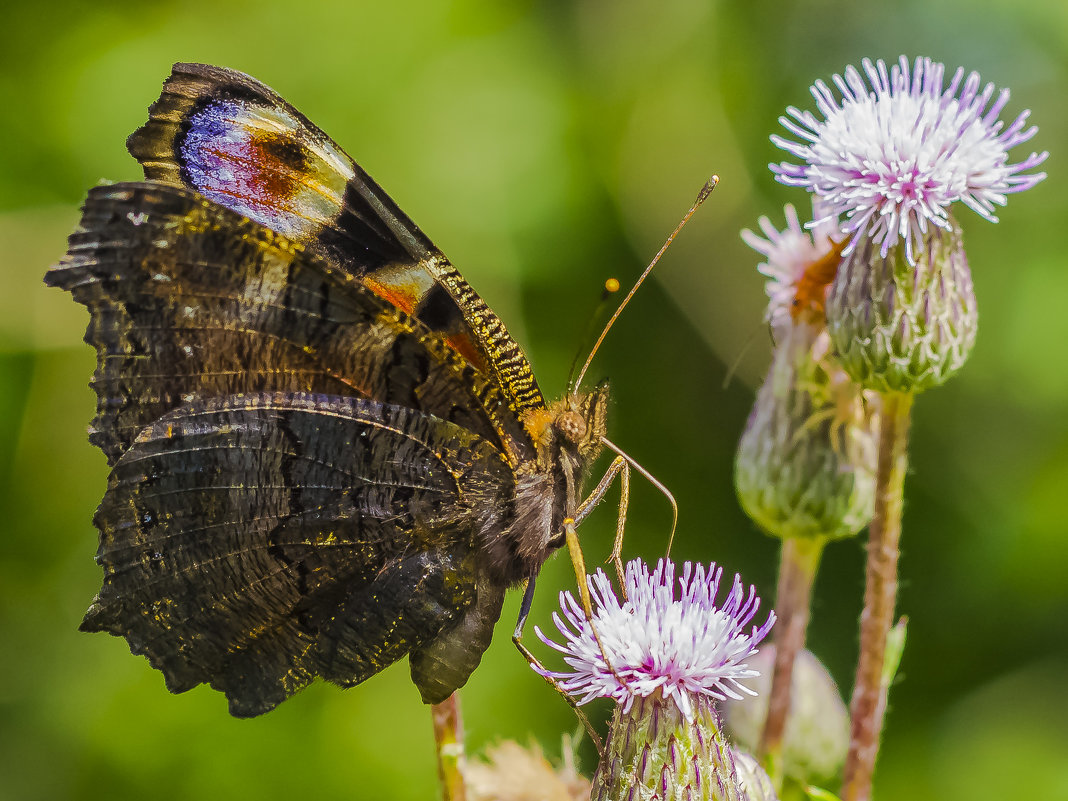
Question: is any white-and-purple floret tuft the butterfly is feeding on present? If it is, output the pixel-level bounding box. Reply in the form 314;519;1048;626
534;560;775;719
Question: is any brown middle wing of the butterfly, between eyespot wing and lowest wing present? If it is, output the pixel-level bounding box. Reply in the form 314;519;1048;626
46;184;514;464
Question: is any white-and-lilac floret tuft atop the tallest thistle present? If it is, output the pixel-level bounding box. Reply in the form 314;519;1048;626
770;56;1049;264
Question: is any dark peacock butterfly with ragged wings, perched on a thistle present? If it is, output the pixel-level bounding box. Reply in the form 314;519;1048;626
46;64;625;717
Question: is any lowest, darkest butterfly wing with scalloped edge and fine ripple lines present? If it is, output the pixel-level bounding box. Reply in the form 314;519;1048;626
82;393;514;716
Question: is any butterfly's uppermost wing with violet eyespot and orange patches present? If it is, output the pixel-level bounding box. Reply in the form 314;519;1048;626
127;64;545;446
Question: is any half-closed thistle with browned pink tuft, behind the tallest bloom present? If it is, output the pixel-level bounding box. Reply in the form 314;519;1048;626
735;206;878;539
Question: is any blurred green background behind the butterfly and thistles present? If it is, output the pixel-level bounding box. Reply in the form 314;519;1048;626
0;0;1068;801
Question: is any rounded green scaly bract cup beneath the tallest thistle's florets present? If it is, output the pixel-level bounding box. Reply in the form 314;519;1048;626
827;218;978;393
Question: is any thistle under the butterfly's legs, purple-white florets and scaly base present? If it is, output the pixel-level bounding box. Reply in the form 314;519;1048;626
535;560;775;801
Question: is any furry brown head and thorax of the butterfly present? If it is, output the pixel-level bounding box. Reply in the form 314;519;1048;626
481;381;609;584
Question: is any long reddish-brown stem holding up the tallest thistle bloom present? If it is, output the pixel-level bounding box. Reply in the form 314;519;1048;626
842;392;912;801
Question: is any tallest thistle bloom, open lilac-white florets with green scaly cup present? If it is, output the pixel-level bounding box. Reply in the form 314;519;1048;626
771;57;1048;393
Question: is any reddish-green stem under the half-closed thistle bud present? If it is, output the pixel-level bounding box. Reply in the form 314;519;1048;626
759;537;827;789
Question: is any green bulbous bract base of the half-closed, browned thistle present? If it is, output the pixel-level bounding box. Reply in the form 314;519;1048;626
735;324;875;539
